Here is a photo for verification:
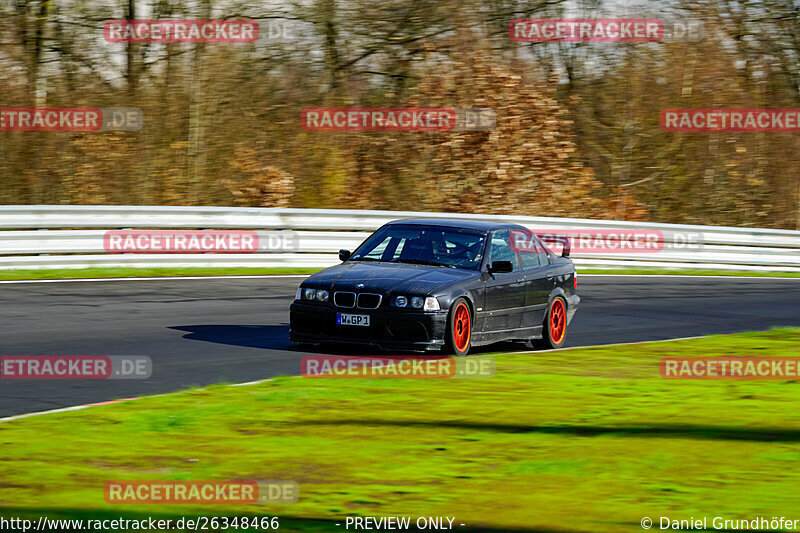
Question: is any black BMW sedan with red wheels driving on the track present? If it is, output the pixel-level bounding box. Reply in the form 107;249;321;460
289;219;580;356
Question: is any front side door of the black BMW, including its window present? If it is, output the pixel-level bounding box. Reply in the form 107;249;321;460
483;230;525;337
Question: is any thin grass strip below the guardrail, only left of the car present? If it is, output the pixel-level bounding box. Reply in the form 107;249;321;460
0;267;321;281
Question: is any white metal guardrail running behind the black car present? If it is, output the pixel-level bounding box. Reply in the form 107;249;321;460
0;205;800;272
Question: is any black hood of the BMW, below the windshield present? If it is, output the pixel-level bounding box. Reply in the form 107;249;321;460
304;262;479;295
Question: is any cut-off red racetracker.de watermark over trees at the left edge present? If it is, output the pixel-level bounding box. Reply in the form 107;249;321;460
0;107;144;131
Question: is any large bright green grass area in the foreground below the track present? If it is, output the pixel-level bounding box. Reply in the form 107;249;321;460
0;329;800;531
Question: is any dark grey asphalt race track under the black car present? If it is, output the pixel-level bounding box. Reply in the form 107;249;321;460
0;276;800;417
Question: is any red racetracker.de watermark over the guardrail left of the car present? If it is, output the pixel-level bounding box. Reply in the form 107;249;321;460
103;230;299;254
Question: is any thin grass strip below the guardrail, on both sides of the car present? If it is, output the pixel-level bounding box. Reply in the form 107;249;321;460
0;267;800;281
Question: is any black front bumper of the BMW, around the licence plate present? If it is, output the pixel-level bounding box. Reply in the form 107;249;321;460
289;301;447;351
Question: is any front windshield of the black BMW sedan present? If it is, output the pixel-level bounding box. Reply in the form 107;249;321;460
350;224;486;270
